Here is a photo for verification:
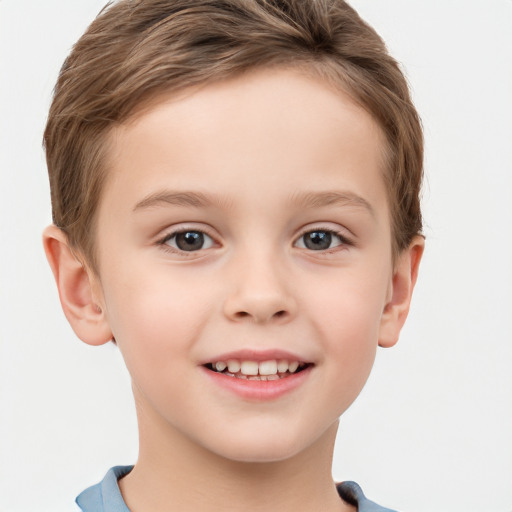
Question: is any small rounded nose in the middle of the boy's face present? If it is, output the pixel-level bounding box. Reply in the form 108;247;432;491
224;254;297;324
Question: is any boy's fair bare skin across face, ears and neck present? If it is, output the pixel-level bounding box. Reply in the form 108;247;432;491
44;70;423;512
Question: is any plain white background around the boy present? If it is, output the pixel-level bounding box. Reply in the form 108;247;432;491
0;0;512;512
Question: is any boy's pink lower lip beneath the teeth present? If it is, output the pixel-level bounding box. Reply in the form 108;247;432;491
202;366;313;402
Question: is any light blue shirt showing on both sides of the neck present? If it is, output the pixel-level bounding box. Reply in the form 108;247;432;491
76;466;395;512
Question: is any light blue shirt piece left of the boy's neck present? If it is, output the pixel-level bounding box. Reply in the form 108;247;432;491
76;466;133;512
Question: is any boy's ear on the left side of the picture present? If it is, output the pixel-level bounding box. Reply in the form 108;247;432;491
43;225;112;345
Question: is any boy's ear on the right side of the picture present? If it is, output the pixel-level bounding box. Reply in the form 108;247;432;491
379;236;425;347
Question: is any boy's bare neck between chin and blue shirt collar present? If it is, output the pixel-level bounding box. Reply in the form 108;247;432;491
119;394;353;512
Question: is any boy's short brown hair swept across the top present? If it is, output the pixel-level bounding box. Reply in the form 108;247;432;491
44;0;423;268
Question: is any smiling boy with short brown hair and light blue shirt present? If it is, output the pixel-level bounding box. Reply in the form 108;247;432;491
44;0;423;512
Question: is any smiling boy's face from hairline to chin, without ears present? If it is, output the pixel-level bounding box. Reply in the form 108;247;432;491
93;70;400;461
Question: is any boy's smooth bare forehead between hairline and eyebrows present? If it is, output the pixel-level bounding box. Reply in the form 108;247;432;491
102;69;385;220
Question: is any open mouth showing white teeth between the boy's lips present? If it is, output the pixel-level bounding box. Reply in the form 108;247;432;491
203;359;313;381
